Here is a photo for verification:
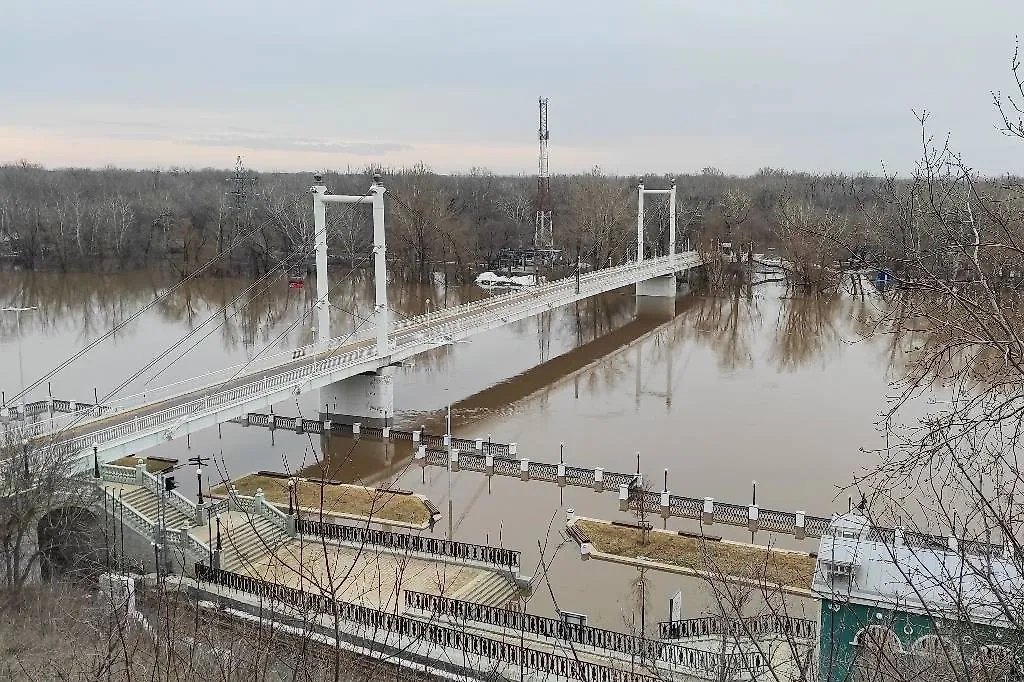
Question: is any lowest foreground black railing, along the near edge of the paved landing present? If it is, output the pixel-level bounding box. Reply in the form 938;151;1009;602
196;562;658;682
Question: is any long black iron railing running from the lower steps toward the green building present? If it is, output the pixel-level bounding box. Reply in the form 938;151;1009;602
404;590;768;680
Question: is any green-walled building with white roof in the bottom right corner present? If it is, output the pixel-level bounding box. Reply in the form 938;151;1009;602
812;513;1024;682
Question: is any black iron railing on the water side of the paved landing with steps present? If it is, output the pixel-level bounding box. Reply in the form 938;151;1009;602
296;518;521;572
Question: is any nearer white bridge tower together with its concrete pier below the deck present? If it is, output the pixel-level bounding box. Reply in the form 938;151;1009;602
309;174;394;426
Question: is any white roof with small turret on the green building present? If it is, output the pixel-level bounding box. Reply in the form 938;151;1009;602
811;513;1024;624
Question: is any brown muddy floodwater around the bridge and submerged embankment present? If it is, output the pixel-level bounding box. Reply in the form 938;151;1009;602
0;272;909;629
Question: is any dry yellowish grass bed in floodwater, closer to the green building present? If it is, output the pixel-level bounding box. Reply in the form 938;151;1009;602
577;519;814;590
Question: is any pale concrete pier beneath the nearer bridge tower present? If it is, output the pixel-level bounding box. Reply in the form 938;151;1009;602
319;367;394;427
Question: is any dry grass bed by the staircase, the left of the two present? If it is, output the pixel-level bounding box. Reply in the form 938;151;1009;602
210;474;430;525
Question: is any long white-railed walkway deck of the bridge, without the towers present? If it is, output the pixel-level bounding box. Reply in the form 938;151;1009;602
24;253;700;468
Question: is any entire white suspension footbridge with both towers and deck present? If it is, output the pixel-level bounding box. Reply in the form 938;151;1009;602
8;176;702;471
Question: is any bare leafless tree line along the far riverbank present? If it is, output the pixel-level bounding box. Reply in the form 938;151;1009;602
0;161;933;281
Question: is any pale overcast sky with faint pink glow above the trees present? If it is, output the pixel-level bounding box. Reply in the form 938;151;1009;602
0;0;1024;174
